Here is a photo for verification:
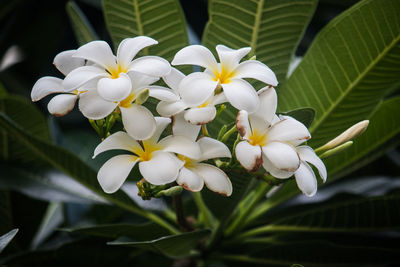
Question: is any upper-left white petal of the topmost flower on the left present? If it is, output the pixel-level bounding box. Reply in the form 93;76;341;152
74;41;117;69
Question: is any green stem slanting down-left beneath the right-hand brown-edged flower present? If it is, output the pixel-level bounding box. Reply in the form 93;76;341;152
225;182;271;236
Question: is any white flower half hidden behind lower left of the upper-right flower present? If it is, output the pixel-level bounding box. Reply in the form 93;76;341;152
153;68;227;125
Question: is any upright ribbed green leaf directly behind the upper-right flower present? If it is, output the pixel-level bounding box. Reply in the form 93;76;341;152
203;0;318;83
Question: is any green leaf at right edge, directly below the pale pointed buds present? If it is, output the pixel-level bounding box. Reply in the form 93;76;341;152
324;96;400;179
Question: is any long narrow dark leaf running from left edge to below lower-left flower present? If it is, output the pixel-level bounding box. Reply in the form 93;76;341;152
0;112;143;214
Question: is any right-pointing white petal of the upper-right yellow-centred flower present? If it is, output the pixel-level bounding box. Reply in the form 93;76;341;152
235;60;278;86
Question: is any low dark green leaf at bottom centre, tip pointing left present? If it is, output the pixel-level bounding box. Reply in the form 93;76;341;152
107;230;210;259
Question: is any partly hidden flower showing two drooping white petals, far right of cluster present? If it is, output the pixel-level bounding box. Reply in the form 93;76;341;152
294;146;327;197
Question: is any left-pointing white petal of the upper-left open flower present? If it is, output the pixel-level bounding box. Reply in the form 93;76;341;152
63;66;108;92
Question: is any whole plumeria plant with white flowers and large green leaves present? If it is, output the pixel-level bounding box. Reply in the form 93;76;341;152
0;0;400;266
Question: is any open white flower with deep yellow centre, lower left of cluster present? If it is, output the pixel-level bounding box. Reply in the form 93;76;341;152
93;117;201;193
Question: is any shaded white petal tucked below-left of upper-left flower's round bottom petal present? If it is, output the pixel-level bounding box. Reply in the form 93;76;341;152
79;89;118;120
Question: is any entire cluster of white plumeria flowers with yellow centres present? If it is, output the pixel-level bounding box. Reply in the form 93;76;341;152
31;36;327;199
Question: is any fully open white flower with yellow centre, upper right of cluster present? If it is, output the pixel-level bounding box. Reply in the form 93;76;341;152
172;45;278;113
